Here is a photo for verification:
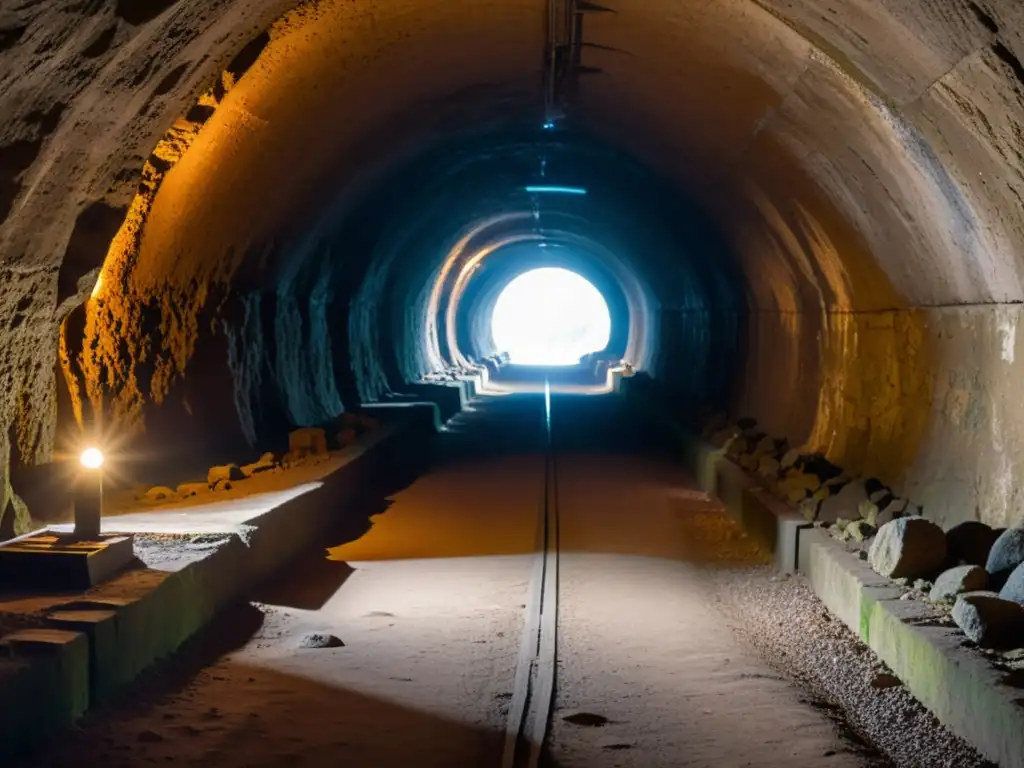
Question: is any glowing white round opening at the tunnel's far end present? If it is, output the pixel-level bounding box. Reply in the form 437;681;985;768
490;267;611;366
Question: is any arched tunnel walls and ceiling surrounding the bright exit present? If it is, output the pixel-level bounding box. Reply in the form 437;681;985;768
0;0;1024;765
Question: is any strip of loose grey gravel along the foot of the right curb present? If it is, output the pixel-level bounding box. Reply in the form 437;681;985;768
708;566;993;768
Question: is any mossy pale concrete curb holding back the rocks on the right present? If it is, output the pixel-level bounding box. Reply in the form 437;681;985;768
622;385;1024;768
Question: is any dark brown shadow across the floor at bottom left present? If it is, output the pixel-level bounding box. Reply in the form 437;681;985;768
14;605;536;768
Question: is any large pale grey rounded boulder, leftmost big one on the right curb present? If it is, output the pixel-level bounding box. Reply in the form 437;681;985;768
867;517;946;579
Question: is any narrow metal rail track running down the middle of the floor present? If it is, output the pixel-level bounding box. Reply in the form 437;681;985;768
502;381;558;768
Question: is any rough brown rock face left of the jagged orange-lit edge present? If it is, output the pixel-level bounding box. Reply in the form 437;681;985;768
0;0;291;525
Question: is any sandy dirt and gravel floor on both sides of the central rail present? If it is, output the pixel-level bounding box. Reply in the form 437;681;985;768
14;396;983;768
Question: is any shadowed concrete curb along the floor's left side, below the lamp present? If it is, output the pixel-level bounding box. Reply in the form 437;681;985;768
0;404;436;762
